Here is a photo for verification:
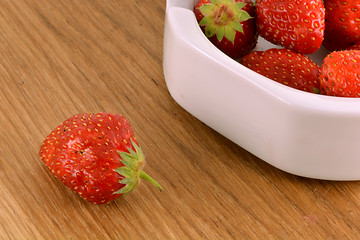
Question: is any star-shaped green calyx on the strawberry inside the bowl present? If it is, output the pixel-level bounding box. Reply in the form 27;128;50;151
199;0;252;44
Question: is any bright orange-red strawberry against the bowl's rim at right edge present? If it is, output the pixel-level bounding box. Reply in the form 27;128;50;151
320;50;360;97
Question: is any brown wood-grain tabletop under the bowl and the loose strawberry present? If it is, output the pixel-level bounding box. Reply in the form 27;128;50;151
0;0;360;240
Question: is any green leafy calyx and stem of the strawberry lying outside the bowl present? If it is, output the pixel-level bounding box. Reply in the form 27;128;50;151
114;140;163;194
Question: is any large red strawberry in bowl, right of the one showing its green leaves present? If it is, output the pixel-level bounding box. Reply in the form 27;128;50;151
256;0;325;54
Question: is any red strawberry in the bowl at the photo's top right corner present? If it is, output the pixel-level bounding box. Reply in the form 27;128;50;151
323;0;360;51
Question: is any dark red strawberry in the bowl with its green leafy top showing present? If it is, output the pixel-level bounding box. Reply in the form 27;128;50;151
194;0;258;59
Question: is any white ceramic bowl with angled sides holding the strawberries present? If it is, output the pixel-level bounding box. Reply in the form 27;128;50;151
163;0;360;180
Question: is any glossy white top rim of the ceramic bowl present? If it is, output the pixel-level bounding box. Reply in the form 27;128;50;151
166;0;360;115
